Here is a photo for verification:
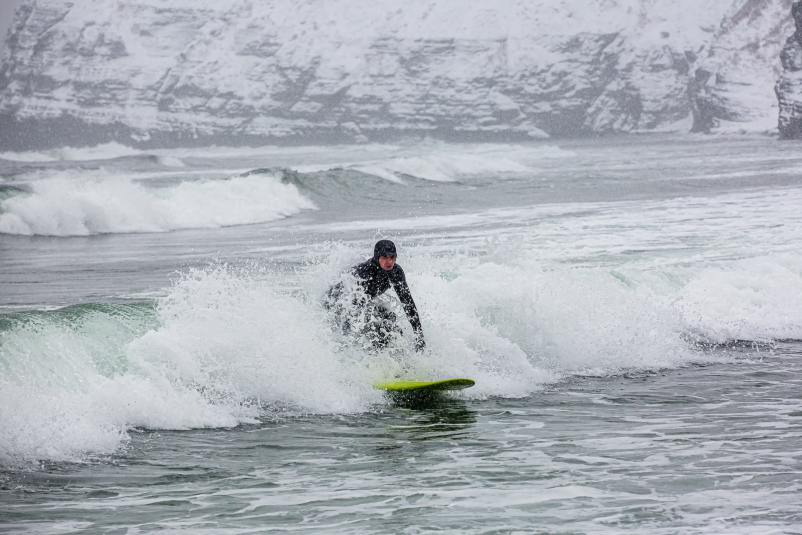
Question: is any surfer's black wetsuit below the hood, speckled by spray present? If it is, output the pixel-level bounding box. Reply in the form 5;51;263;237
327;257;425;350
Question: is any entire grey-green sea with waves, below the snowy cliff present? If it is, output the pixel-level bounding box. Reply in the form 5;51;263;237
0;136;802;534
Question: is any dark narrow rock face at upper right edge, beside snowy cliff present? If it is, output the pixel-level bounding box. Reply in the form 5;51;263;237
775;1;802;139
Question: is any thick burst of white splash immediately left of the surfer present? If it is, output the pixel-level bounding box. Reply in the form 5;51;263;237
129;267;366;412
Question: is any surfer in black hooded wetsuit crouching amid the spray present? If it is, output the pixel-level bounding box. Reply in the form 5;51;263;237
325;240;426;351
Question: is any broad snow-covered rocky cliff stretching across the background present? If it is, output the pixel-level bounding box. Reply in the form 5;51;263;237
0;0;792;150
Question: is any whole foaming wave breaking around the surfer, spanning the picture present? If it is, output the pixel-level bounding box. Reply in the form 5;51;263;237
7;244;802;464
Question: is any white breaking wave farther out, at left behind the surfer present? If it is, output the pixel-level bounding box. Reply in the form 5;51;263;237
0;172;316;236
